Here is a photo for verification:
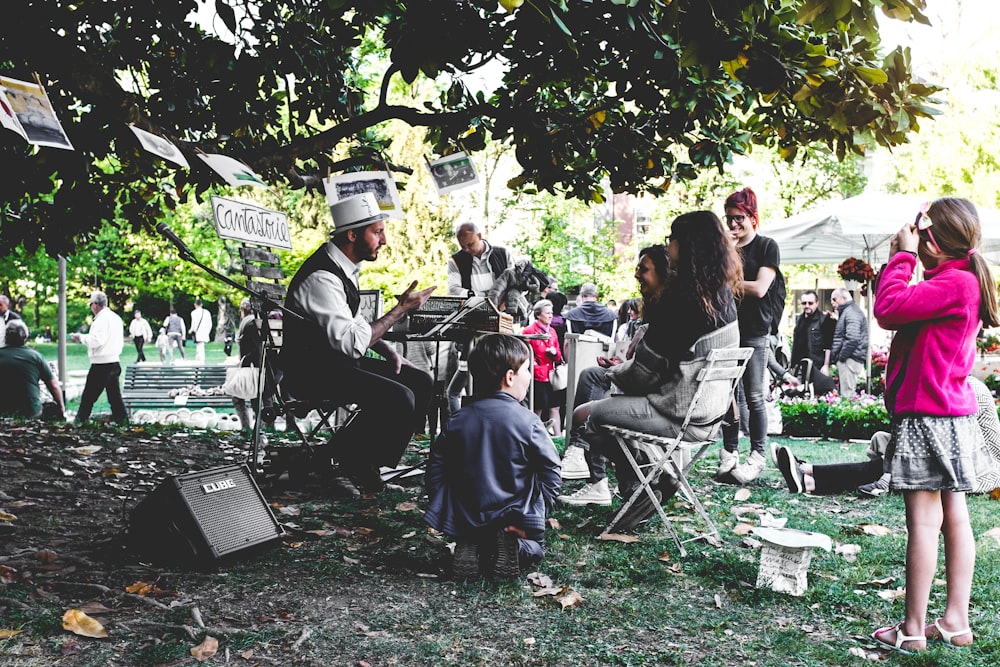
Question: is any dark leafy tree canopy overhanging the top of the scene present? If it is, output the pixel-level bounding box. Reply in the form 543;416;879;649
0;0;936;254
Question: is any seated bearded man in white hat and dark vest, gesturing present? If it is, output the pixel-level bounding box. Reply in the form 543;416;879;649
281;192;434;490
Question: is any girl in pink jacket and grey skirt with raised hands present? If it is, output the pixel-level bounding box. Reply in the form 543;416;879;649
872;197;1000;652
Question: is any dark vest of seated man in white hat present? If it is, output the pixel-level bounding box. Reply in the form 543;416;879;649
281;246;361;373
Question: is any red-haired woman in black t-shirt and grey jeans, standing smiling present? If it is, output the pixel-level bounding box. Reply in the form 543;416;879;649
719;188;781;484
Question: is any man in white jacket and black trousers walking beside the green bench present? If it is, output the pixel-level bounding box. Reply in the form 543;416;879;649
72;292;128;424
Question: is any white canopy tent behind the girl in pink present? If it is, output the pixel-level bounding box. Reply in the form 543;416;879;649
760;193;1000;270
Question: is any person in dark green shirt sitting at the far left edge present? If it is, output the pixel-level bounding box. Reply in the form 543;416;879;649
0;319;66;419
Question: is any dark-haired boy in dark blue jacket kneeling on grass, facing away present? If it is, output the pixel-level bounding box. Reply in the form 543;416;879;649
424;334;562;580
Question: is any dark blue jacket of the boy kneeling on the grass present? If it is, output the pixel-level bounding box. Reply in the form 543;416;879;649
424;391;562;541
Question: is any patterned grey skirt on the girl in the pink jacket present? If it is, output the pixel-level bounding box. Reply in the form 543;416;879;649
886;415;996;492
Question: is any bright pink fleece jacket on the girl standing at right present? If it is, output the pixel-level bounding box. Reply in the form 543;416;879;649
875;252;981;417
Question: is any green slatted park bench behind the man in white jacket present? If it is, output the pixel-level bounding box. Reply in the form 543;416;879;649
122;364;233;411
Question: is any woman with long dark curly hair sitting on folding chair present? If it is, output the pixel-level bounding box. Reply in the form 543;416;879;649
561;211;742;530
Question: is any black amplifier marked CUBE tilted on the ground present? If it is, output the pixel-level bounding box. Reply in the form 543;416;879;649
129;465;285;565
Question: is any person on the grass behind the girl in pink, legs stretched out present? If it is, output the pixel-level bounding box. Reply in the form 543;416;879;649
776;376;1000;496
